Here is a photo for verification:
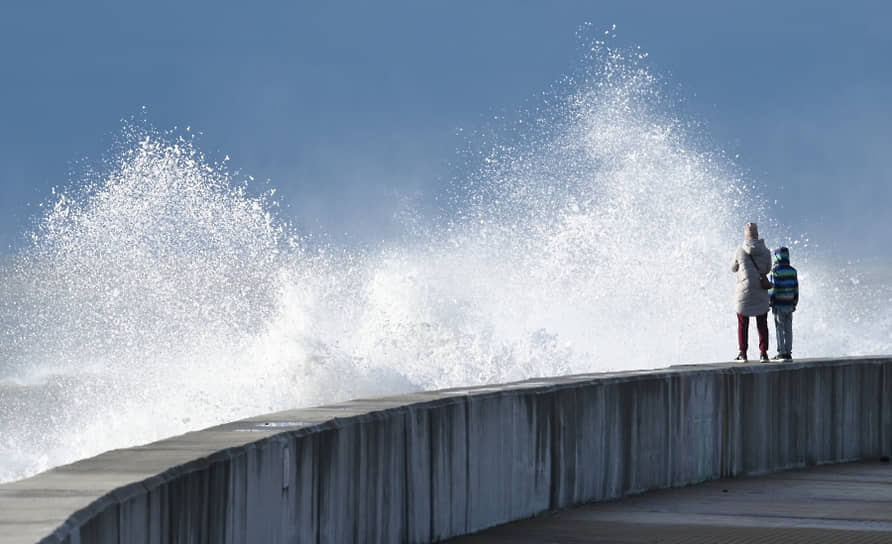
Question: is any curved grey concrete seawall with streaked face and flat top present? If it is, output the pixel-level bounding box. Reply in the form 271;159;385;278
0;357;892;544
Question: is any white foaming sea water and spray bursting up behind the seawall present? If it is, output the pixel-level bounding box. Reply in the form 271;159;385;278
0;44;892;481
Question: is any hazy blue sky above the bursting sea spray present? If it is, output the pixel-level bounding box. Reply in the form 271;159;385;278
0;0;892;255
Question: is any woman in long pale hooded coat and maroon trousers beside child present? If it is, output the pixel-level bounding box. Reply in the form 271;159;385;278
731;223;771;363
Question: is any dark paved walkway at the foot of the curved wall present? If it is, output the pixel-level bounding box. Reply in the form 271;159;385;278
448;462;892;544
